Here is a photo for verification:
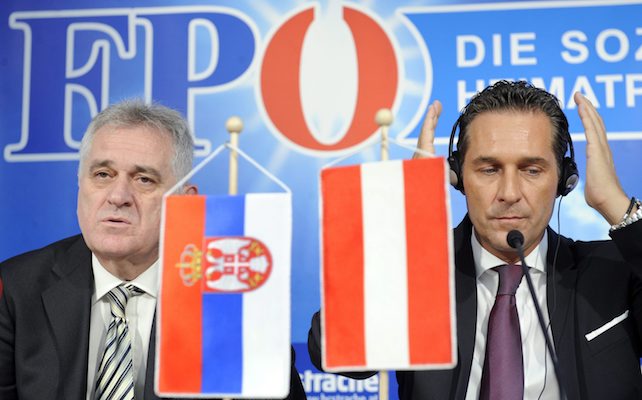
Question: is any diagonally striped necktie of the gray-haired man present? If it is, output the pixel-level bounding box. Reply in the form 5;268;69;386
94;284;144;400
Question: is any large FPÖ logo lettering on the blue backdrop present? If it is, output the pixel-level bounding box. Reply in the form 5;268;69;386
3;1;424;162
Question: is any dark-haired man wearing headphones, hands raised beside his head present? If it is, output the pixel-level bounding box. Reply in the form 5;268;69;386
308;81;642;400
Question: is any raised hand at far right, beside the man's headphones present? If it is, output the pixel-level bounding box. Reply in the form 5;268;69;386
573;92;629;225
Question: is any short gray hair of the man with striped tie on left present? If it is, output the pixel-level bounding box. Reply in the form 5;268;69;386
78;99;194;180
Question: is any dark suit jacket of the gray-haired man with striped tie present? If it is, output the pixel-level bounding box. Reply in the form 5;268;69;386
0;236;305;400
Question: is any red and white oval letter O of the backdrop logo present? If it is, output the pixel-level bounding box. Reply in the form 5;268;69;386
258;2;402;153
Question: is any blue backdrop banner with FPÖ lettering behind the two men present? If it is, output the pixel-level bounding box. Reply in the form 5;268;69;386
0;0;642;400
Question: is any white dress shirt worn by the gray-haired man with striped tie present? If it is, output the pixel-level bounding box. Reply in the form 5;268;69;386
87;254;159;400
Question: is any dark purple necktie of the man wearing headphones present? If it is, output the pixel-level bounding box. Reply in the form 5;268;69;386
479;265;524;400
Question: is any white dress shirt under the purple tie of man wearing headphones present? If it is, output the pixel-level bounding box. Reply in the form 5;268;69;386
466;232;559;400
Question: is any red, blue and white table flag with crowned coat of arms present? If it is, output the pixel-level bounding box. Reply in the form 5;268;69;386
155;193;292;398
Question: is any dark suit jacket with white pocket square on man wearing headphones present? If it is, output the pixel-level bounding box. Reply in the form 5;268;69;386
308;217;642;400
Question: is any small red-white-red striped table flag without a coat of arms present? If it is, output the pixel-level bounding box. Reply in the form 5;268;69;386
321;158;456;371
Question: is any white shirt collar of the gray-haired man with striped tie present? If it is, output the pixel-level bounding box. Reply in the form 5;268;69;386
91;253;159;304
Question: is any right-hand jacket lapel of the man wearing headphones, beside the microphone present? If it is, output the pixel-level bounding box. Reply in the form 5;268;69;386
546;228;580;399
